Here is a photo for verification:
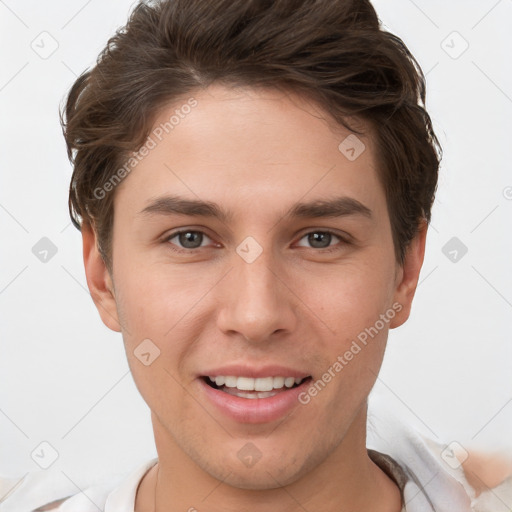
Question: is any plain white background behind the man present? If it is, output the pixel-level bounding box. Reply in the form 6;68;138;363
0;0;512;488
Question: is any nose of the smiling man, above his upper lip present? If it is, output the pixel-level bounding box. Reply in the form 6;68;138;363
217;252;297;343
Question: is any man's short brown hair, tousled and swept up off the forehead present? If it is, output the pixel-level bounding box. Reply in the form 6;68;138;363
61;0;441;270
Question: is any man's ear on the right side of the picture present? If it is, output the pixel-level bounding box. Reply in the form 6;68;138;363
390;220;428;329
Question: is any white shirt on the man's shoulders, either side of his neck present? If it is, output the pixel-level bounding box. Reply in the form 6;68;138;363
0;402;512;512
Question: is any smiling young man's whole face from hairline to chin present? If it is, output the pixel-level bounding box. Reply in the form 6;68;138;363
85;86;420;489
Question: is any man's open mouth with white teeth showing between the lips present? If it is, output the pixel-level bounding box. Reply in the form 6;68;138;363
201;375;312;400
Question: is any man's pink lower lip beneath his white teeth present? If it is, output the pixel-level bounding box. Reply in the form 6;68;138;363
199;378;311;423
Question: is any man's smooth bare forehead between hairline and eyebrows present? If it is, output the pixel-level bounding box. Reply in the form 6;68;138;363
116;85;385;219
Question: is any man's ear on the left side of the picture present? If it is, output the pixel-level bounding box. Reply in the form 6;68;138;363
81;223;121;332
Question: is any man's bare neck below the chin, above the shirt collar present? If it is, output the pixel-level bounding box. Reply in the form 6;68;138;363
135;405;401;512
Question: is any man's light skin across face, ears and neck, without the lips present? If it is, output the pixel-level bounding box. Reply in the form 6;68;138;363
82;85;426;512
